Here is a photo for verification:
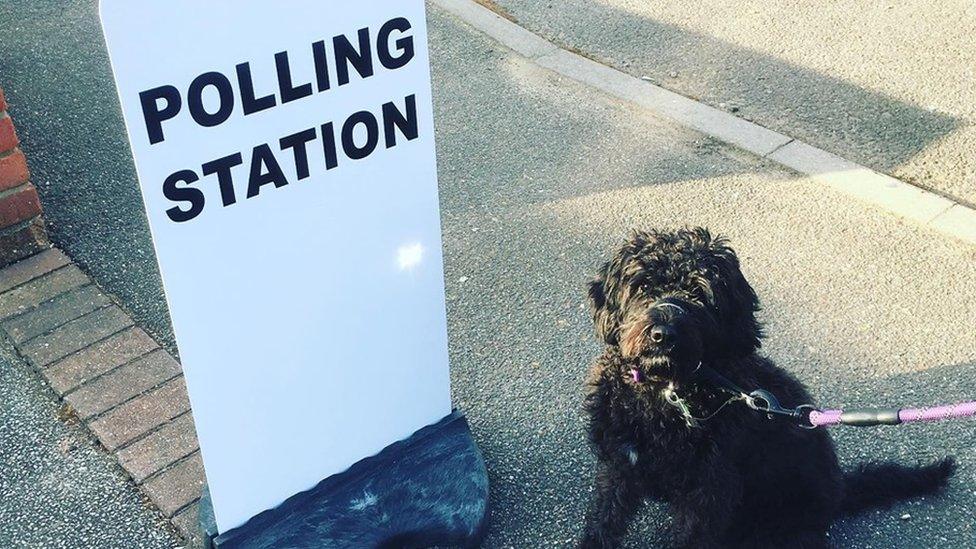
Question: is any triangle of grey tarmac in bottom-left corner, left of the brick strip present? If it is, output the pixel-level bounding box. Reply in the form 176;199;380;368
0;342;182;549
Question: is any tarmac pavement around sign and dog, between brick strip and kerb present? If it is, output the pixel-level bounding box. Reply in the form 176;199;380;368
0;1;976;548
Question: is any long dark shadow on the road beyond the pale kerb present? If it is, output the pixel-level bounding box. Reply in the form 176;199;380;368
498;0;965;193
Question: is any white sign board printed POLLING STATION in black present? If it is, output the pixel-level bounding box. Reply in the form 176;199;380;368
101;0;451;532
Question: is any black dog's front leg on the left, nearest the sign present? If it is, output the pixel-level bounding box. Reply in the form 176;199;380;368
579;463;641;549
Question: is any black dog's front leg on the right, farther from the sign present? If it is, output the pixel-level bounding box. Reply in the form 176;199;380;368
670;458;742;549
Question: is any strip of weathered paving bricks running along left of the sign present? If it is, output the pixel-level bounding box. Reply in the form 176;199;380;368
0;249;204;545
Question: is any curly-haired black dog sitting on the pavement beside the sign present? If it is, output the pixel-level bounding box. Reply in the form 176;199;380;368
581;228;955;549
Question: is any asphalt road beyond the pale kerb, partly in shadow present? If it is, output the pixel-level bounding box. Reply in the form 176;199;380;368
494;0;976;206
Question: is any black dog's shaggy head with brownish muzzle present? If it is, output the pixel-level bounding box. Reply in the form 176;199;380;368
589;228;762;378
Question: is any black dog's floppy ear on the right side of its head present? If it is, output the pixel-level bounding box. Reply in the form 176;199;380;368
709;237;763;356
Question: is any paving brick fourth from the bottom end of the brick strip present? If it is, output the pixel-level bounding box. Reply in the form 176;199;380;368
88;376;190;451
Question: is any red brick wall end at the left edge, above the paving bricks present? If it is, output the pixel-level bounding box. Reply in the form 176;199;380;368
0;88;51;267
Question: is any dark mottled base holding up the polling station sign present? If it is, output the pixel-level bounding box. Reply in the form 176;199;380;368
200;411;488;549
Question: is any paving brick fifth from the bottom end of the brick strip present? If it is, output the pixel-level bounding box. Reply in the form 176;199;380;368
64;349;181;419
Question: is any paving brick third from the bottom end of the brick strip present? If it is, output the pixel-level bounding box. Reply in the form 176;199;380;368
118;414;199;484
